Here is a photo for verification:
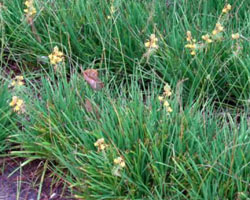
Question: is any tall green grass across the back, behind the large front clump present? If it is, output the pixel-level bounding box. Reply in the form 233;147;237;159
1;0;250;107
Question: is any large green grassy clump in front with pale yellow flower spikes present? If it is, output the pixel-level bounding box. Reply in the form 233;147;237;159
8;71;250;199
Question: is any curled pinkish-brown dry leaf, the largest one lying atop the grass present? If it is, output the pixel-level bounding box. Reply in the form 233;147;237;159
83;69;104;90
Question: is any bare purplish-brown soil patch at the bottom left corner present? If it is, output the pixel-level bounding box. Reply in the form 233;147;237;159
0;158;73;200
